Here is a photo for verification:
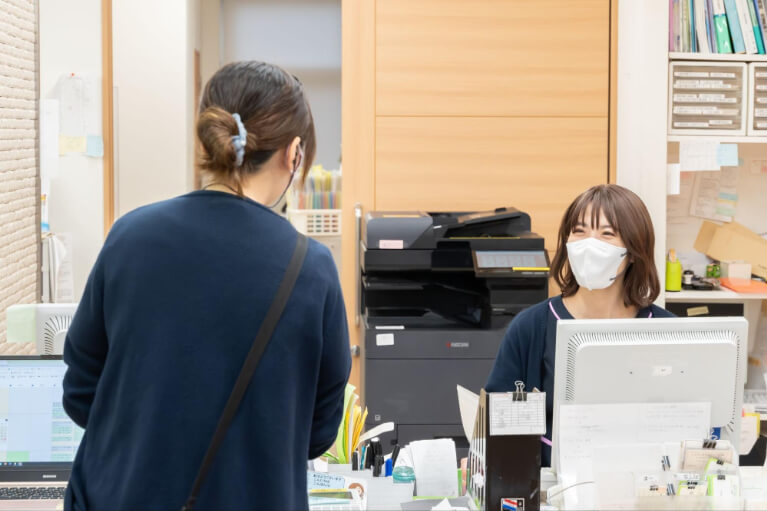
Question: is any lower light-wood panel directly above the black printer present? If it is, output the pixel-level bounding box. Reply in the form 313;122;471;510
375;118;608;250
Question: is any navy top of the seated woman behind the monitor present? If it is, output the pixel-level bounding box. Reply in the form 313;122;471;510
485;296;673;466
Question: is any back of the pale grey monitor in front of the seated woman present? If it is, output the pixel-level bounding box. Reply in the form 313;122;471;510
552;317;748;461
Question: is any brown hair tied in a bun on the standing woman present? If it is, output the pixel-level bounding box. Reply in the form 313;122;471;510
197;61;317;192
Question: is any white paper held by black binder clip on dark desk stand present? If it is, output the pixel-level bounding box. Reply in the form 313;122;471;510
489;392;546;436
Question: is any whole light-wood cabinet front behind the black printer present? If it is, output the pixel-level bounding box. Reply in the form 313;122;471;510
342;0;614;392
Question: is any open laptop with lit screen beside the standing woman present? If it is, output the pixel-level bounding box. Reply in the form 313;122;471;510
0;355;83;511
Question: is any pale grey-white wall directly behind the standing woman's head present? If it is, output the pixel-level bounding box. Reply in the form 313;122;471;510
221;0;341;168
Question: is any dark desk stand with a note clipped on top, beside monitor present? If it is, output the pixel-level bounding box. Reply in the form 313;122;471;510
467;382;546;511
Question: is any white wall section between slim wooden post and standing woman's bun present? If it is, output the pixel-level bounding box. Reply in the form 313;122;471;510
112;0;199;216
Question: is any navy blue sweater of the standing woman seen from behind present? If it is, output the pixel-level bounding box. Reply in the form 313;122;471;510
64;191;351;511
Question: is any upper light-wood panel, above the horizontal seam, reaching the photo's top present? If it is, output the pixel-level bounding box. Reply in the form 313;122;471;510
371;0;610;117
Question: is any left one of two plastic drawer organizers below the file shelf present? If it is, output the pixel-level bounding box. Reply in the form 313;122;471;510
668;61;748;136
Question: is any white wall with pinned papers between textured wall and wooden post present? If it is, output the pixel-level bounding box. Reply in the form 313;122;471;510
40;0;104;299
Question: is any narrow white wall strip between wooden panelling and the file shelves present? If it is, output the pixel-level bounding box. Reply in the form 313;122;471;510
617;0;668;305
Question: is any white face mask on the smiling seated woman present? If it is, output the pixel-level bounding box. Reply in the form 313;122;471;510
567;238;627;289
